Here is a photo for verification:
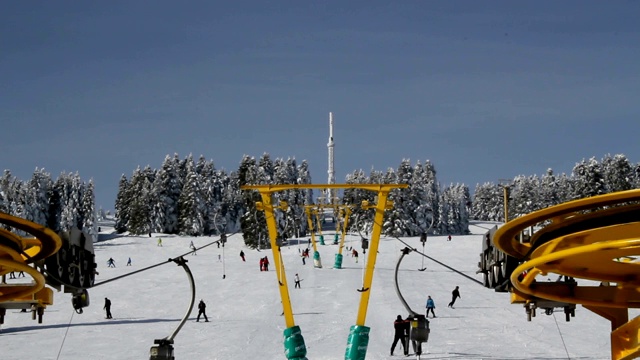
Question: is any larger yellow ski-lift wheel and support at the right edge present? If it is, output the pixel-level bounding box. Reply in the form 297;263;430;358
493;190;640;359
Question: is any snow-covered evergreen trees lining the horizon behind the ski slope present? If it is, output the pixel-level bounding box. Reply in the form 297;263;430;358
0;153;640;248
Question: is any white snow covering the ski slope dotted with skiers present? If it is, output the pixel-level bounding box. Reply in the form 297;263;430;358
0;224;610;360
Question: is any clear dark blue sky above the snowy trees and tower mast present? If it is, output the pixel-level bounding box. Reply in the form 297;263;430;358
0;0;640;209
